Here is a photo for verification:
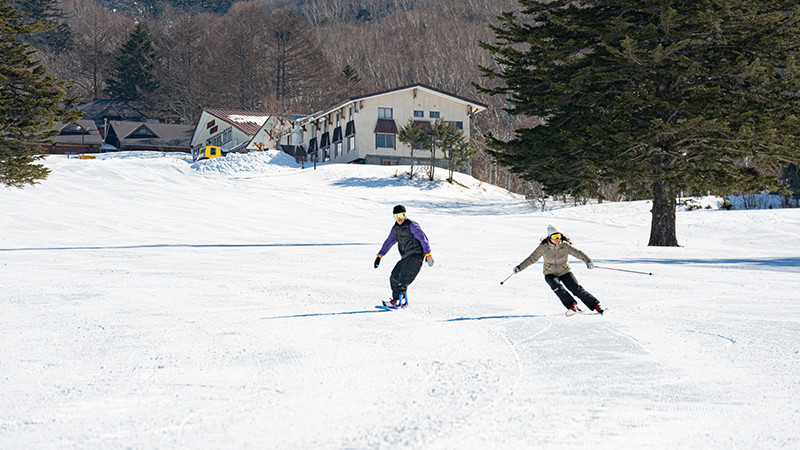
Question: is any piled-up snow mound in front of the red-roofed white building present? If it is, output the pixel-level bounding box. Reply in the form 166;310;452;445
191;150;300;175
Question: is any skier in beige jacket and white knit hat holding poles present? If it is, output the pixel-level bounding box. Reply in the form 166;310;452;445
514;225;603;316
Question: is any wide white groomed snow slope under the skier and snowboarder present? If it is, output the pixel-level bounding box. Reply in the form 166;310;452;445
0;153;800;449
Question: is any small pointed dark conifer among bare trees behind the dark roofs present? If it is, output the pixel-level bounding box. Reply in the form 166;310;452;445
105;22;158;100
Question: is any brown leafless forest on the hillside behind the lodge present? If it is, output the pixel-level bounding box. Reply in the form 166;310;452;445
10;0;532;191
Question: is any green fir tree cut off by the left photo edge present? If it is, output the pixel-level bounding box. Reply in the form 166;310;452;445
0;0;78;188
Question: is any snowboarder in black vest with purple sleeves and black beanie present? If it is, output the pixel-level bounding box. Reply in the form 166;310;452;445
375;205;433;308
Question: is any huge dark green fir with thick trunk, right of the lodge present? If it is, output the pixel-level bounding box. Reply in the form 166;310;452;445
481;0;800;246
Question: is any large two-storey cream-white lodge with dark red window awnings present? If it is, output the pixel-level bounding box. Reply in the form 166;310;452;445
247;84;486;165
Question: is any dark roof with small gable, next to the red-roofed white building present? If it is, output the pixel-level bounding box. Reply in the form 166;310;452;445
108;120;194;150
